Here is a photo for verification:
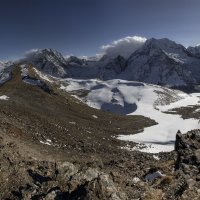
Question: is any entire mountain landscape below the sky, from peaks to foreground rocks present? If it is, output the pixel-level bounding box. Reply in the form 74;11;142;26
0;38;200;200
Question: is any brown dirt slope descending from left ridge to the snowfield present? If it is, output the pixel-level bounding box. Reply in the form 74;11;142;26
0;66;168;199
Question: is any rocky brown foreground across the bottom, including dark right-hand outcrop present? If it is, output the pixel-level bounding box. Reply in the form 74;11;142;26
0;130;200;200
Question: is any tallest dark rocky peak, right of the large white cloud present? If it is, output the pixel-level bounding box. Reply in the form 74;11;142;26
121;39;197;86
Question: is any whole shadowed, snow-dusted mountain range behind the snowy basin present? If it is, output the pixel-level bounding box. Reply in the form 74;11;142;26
18;38;200;87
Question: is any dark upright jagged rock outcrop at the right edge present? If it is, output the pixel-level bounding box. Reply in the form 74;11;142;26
175;130;200;200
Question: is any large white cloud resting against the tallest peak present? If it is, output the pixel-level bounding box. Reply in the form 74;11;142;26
101;36;147;58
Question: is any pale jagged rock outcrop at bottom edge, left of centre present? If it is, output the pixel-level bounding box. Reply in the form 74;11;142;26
4;162;127;200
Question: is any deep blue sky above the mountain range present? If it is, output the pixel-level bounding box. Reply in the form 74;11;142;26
0;0;200;60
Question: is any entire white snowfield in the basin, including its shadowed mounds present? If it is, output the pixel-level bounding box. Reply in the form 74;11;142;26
61;79;200;153
